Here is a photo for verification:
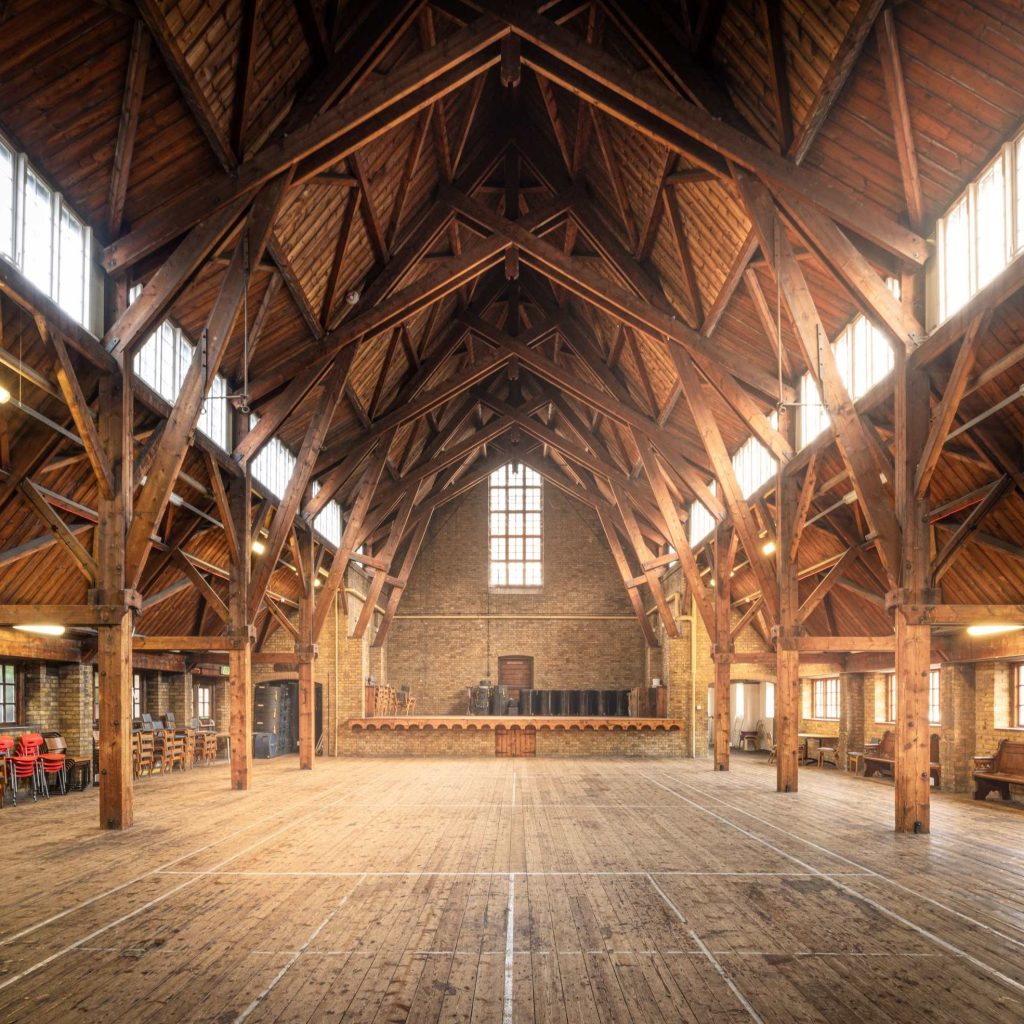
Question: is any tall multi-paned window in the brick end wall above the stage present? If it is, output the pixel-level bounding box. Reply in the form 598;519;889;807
488;465;543;587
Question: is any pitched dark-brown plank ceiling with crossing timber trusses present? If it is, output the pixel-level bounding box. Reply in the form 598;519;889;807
0;0;1024;655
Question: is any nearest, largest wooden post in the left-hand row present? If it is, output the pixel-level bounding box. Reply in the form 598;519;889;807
96;368;134;829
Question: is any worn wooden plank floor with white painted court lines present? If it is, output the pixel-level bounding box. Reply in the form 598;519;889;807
0;757;1024;1024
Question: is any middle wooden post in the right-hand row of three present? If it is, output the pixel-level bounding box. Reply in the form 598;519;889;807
774;463;802;793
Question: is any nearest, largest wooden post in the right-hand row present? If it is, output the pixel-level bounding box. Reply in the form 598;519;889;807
887;356;938;833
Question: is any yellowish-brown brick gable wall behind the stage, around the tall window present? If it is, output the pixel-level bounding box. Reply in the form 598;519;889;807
386;484;646;715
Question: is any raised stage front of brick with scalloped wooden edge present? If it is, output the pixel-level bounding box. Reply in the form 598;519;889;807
338;715;689;757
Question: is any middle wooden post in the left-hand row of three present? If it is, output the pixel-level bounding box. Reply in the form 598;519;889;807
227;414;253;790
